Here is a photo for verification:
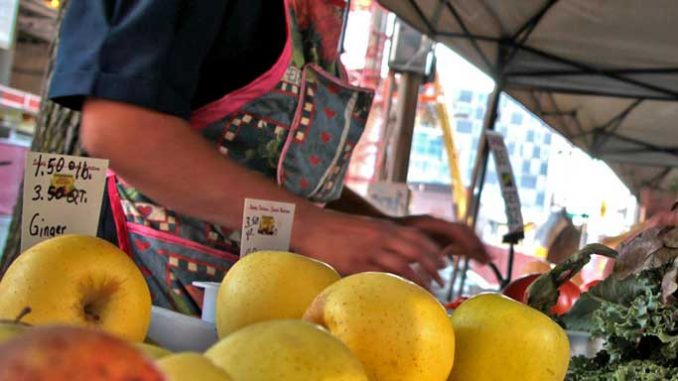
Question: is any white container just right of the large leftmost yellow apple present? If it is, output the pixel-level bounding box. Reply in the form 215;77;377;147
148;306;219;352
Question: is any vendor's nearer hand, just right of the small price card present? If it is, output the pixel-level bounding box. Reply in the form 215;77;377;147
292;210;452;287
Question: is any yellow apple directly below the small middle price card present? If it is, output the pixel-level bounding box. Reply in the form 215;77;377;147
216;251;340;337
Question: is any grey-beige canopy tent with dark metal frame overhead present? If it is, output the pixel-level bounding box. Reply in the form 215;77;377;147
379;0;678;193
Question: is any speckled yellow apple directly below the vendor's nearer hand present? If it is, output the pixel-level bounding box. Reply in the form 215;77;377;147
304;272;454;381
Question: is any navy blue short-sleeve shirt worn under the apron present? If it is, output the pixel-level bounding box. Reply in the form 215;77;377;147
49;0;285;119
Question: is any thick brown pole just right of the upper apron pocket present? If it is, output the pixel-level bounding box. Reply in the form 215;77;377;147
388;73;423;183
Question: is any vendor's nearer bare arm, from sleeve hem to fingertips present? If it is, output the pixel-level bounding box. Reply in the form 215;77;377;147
81;99;443;281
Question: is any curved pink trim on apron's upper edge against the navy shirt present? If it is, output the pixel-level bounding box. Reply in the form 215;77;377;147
191;0;292;130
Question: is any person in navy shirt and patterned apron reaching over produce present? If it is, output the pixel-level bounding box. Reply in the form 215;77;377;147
49;0;488;313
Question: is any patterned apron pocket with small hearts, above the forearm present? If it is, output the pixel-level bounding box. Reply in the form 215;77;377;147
277;64;373;202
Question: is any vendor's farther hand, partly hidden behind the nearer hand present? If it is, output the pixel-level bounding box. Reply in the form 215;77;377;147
394;216;491;263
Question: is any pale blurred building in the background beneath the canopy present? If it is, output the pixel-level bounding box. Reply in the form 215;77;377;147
408;85;636;248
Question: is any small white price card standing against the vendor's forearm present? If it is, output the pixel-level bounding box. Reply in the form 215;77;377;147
240;198;294;257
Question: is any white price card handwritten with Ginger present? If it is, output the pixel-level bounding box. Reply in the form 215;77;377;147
21;152;108;251
